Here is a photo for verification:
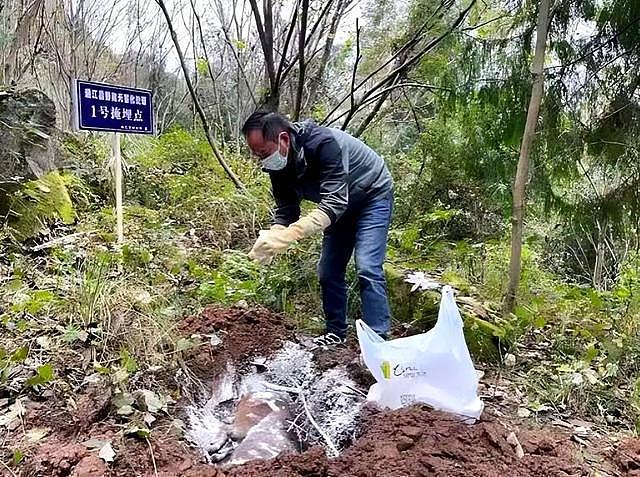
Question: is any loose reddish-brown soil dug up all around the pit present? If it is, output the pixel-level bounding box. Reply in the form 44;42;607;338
12;308;640;477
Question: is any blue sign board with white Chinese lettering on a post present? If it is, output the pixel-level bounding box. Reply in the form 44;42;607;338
73;80;154;134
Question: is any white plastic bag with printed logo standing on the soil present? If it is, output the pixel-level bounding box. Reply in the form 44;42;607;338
356;286;483;418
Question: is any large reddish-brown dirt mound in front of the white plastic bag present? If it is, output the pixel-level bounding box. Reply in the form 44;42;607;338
227;407;589;477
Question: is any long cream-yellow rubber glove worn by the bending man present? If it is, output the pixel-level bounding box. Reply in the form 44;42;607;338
249;209;331;264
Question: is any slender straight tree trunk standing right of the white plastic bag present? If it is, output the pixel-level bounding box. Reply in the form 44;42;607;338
502;0;550;315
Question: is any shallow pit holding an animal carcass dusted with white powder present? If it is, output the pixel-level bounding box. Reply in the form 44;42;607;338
186;341;366;467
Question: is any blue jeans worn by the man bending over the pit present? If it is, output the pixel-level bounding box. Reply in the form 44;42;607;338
318;193;393;338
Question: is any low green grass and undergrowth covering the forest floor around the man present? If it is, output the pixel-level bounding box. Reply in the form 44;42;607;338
0;126;640;432
